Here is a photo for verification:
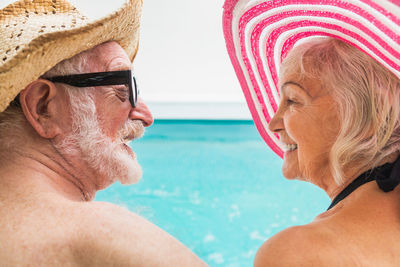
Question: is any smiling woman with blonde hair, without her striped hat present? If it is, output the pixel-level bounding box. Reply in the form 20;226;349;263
256;36;400;266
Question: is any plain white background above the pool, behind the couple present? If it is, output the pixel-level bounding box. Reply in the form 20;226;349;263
0;0;250;119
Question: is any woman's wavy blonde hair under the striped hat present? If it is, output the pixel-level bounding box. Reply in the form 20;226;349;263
280;38;400;185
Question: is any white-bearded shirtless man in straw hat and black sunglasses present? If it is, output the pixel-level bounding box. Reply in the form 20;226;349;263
0;0;205;266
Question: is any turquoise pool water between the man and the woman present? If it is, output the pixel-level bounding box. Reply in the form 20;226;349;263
96;121;330;267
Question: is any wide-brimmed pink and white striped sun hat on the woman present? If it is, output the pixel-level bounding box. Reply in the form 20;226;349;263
223;0;400;157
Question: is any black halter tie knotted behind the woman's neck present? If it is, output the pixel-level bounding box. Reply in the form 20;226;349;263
327;157;400;210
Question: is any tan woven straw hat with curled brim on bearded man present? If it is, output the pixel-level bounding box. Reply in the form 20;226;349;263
0;0;142;112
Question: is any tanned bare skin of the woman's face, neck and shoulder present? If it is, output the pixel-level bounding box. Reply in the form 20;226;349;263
254;71;400;267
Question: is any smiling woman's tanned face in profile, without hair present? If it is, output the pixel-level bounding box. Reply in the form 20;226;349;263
269;72;339;198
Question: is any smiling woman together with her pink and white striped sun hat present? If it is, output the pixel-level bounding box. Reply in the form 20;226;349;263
224;0;400;266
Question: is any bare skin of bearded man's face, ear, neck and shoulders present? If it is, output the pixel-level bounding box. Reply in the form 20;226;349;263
0;42;206;267
